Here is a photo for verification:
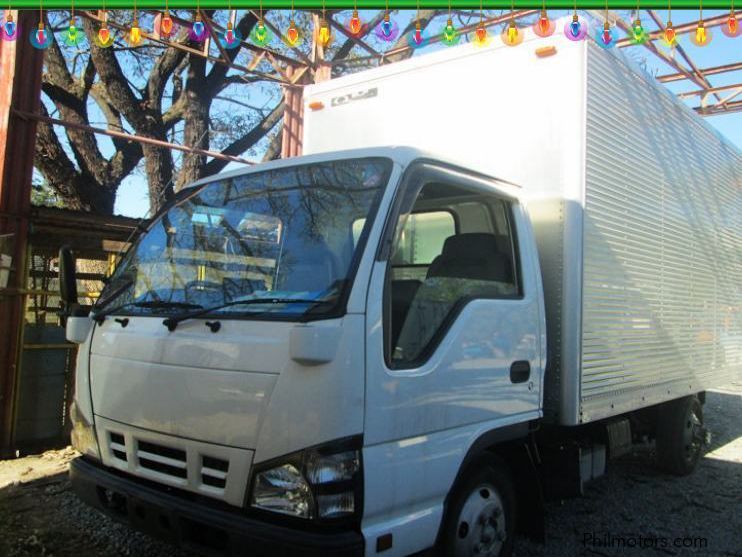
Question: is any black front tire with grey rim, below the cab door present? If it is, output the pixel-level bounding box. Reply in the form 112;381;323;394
438;455;516;557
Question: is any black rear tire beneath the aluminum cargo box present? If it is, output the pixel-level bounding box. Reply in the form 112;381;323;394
657;395;706;476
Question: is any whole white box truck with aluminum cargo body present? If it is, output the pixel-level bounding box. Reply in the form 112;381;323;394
61;28;742;557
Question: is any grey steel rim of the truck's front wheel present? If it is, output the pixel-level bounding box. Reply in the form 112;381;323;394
454;484;507;557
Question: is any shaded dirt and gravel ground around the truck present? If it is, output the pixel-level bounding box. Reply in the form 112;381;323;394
0;383;742;557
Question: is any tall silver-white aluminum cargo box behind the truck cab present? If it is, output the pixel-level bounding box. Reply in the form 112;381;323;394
303;28;742;425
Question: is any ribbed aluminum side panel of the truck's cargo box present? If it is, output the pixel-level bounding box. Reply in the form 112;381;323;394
580;44;742;422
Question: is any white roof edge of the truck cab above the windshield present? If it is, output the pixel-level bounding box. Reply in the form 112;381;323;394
186;145;519;194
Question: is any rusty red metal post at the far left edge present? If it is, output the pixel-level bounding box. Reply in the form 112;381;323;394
0;10;44;455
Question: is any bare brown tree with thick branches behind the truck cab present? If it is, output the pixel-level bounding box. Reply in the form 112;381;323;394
35;10;436;214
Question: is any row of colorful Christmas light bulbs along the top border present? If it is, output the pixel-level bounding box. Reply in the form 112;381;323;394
0;0;742;49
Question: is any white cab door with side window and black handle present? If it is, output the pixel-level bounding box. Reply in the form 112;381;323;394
365;163;545;444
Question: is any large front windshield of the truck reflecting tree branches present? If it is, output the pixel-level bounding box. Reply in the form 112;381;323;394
95;158;392;318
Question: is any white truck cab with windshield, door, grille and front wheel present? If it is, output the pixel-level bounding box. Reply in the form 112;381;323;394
63;147;546;556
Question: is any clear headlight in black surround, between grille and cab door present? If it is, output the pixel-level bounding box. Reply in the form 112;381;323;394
250;442;363;521
